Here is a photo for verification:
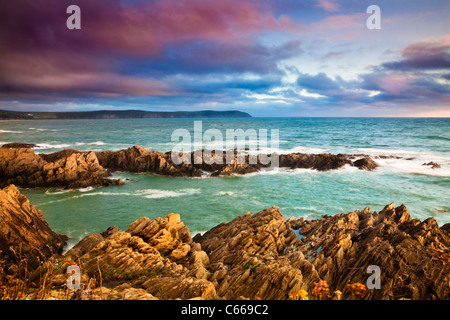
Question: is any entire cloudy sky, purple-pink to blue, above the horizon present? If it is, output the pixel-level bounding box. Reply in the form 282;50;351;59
0;0;450;117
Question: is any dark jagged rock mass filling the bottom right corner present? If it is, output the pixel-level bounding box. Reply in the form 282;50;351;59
292;203;450;299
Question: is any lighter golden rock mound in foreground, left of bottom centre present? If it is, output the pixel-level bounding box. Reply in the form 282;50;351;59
62;214;219;299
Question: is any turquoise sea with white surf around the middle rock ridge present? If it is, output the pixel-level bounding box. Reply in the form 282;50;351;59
0;118;450;249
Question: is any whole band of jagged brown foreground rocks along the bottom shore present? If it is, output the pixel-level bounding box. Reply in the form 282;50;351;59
0;186;450;299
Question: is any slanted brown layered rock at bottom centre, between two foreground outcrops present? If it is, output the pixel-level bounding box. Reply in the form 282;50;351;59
194;207;319;299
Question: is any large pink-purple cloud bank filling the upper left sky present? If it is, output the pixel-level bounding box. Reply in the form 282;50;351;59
0;0;298;100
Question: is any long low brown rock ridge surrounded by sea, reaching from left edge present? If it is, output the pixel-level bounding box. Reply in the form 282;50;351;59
0;144;377;188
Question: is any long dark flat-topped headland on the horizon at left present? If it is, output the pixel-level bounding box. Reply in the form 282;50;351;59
0;110;251;120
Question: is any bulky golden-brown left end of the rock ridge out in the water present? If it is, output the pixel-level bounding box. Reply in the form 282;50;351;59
0;147;123;188
